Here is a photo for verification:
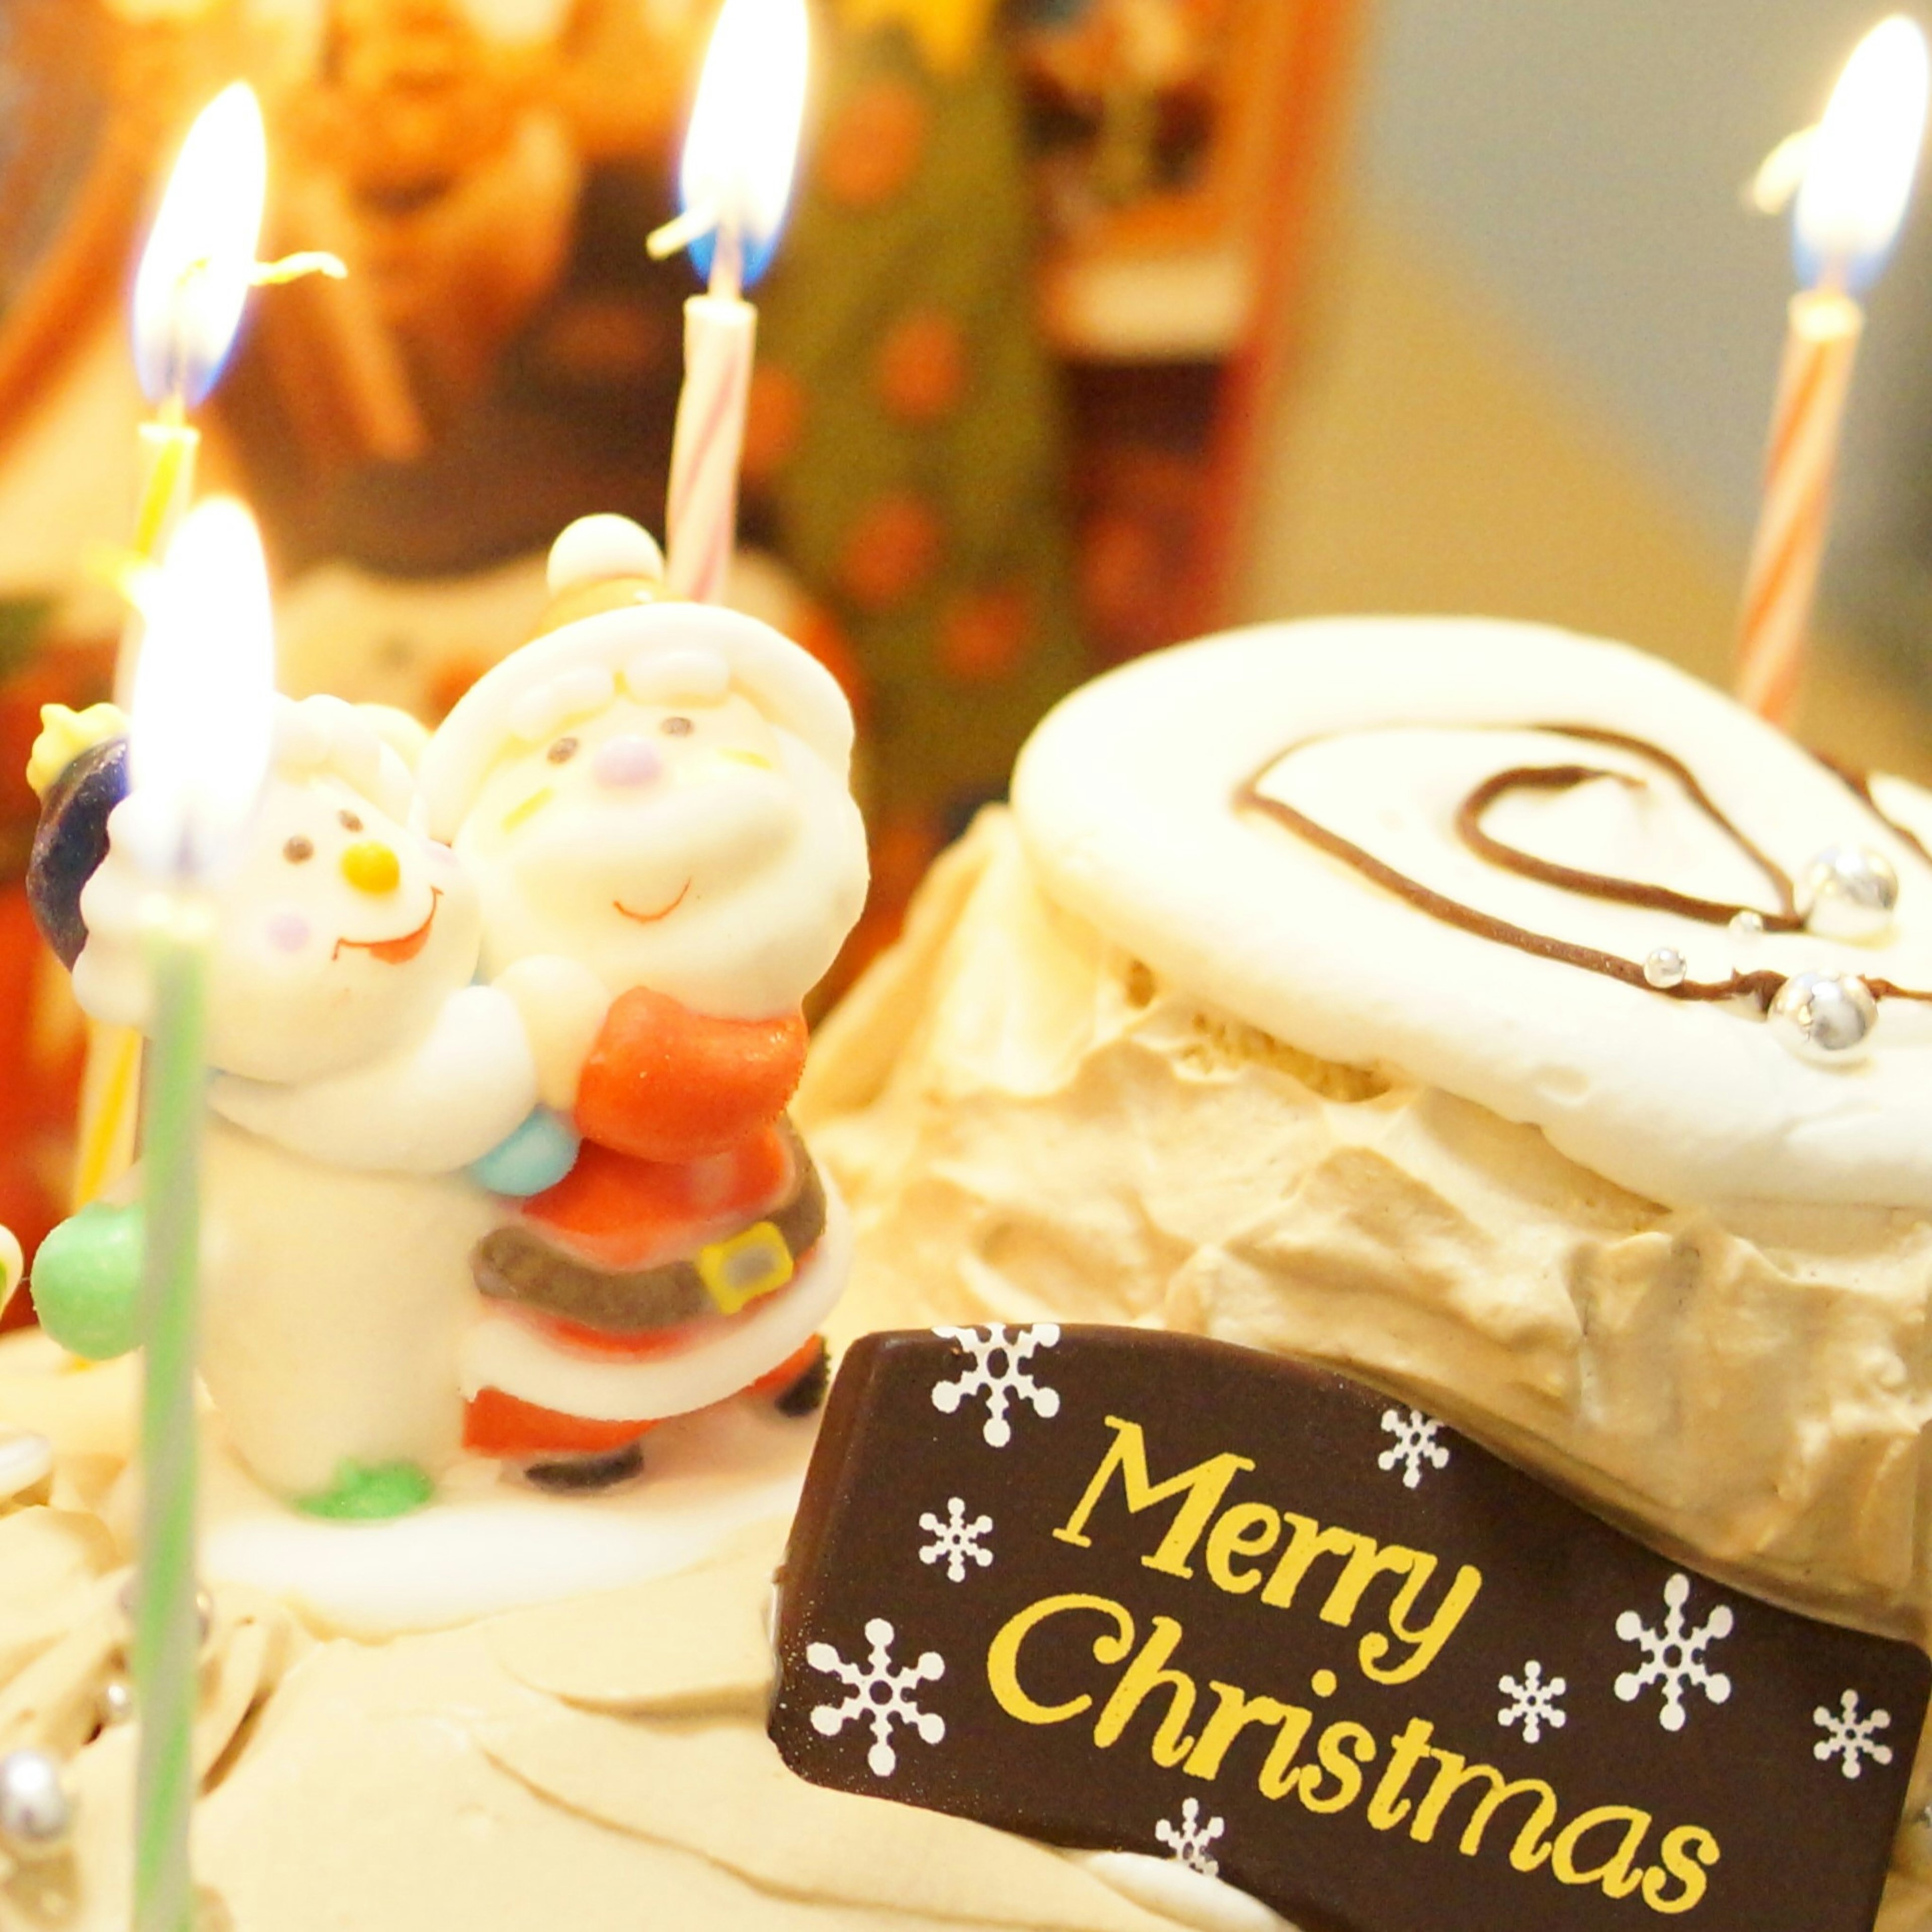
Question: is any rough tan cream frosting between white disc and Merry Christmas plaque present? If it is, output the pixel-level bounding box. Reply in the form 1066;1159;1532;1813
802;810;1932;1932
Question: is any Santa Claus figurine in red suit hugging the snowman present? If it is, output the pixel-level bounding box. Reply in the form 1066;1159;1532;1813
431;516;865;1491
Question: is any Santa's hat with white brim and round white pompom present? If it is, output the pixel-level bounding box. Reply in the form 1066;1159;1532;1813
417;516;852;839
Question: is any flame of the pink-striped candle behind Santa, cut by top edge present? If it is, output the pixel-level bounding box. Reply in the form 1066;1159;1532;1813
678;0;808;284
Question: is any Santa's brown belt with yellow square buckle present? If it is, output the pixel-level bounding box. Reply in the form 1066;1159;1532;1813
469;1122;825;1335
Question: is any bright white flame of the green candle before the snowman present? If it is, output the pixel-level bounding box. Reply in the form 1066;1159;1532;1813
125;497;274;879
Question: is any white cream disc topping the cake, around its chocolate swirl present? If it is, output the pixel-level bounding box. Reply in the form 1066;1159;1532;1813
1014;618;1932;1210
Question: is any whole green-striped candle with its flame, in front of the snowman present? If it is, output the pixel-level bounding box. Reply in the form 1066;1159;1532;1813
114;497;274;1932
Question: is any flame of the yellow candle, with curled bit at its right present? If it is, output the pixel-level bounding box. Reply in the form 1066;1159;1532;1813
133;81;269;408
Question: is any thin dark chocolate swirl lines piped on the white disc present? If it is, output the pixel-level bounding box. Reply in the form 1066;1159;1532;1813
1235;725;1932;1014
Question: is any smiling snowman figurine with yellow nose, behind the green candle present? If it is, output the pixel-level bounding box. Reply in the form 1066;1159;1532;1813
31;697;535;1515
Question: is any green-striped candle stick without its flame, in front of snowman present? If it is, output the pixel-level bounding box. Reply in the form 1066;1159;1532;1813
133;887;211;1932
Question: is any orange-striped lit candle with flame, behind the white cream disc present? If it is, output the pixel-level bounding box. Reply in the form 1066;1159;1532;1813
1737;16;1926;725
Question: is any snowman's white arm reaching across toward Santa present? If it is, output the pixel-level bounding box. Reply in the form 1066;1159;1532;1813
209;985;537;1175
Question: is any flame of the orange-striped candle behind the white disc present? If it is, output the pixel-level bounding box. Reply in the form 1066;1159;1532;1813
1793;14;1926;292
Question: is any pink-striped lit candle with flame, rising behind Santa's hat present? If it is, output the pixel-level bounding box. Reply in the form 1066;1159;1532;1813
651;0;808;603
